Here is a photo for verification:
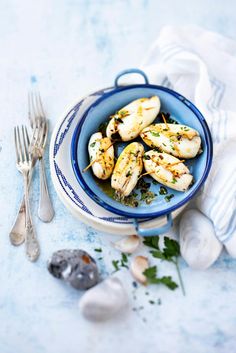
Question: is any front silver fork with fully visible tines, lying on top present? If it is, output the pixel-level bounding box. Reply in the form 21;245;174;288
14;126;39;261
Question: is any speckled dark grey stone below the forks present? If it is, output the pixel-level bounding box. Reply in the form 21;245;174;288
48;249;99;289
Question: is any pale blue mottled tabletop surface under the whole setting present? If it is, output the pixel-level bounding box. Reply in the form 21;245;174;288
0;0;236;353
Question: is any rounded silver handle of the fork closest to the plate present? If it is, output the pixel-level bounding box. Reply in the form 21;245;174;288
38;157;54;222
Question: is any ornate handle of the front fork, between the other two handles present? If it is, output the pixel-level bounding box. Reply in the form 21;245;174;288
24;174;39;261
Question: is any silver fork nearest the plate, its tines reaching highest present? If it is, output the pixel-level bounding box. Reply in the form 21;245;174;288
28;91;54;222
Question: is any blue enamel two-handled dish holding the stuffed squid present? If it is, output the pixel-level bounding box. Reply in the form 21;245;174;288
71;69;213;235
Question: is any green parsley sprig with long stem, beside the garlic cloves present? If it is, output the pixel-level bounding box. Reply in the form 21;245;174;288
143;237;185;295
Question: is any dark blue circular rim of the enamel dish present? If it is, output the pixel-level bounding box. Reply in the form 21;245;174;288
71;84;213;219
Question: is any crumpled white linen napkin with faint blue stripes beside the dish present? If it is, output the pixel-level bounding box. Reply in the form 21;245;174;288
142;26;236;257
